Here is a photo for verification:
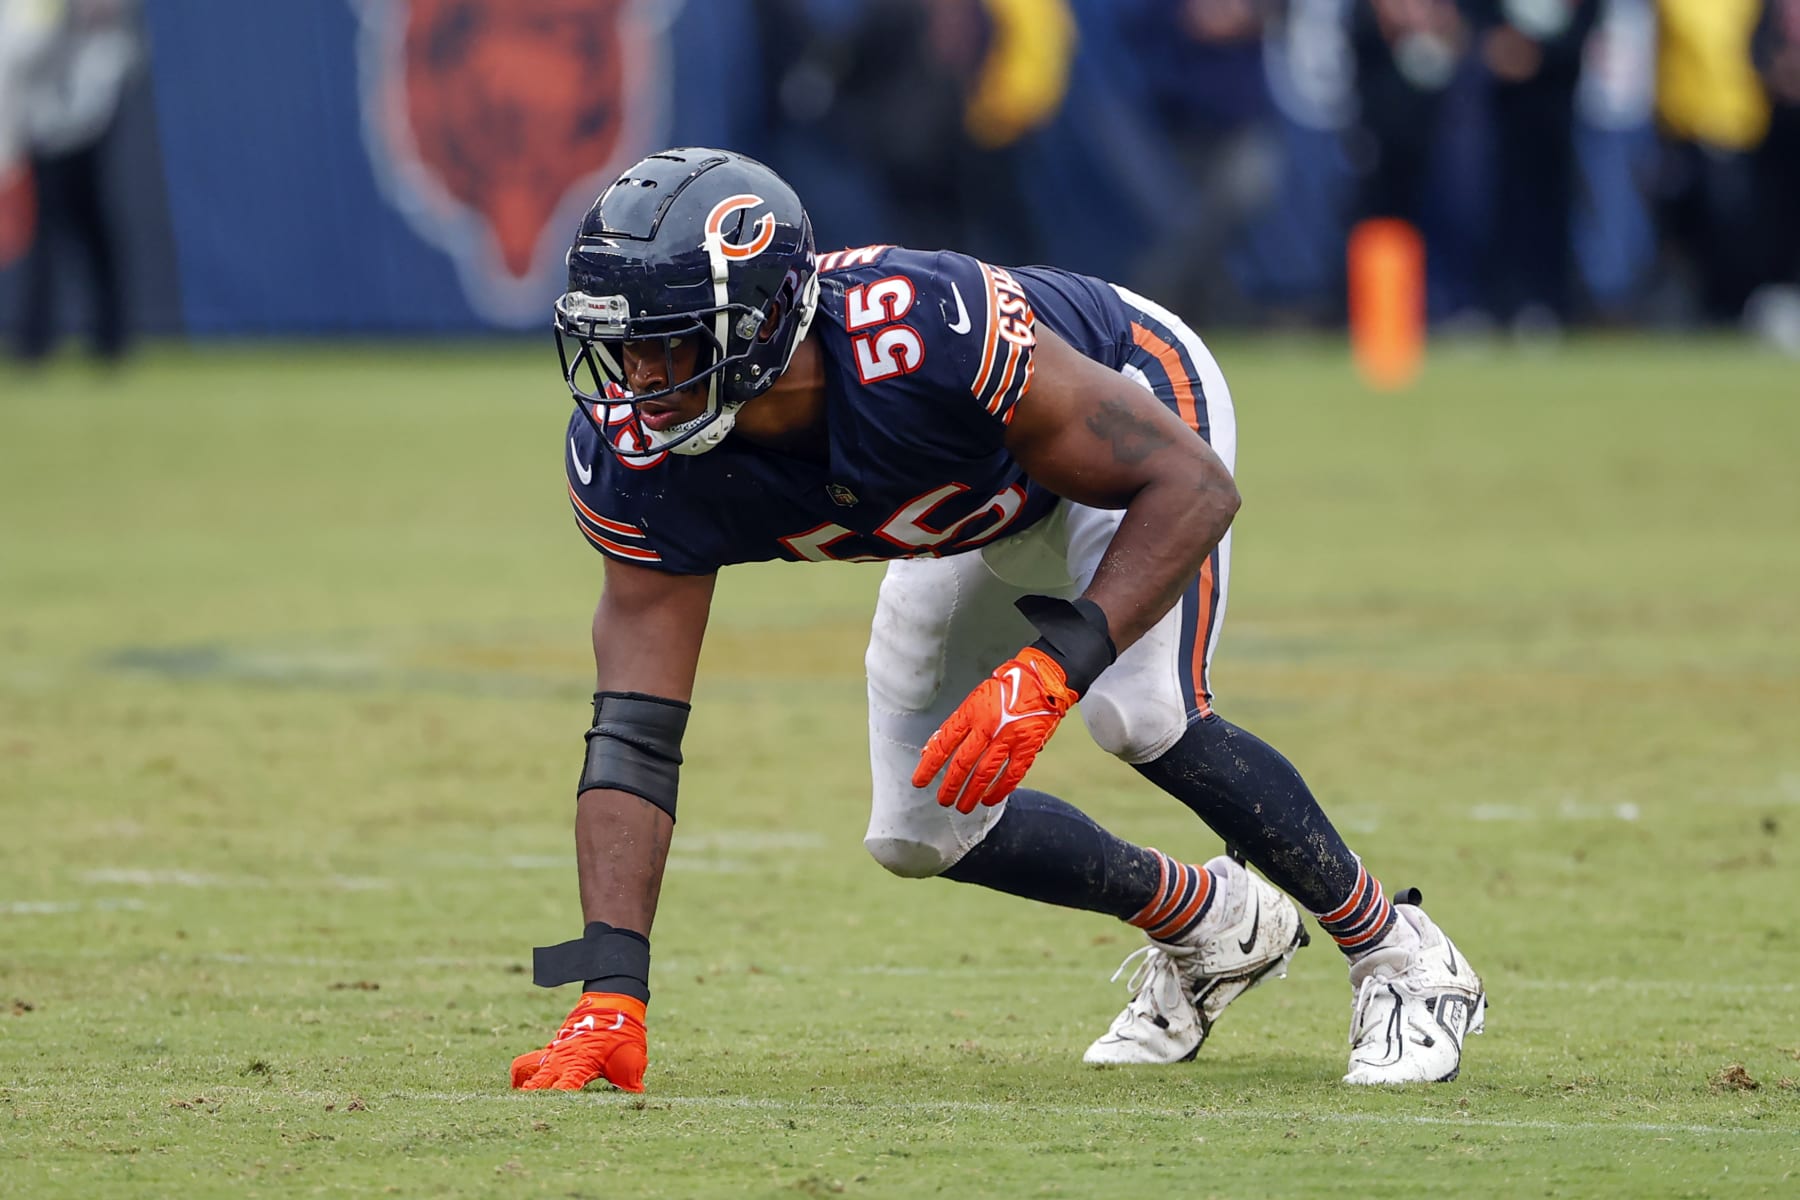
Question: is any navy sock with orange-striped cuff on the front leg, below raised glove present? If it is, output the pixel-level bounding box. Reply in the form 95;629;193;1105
943;788;1213;941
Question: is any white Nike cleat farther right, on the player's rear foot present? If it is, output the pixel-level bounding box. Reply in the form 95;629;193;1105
1345;889;1487;1083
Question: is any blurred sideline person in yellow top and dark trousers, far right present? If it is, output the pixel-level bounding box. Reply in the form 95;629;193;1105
1656;0;1771;320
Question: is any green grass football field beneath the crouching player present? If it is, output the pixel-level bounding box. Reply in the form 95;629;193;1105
0;332;1800;1198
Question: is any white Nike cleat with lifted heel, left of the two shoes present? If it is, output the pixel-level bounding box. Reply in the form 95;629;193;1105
1082;856;1309;1065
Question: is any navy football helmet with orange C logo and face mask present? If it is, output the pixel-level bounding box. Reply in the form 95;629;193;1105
554;148;819;459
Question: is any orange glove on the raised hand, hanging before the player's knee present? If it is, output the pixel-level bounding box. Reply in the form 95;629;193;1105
913;646;1078;813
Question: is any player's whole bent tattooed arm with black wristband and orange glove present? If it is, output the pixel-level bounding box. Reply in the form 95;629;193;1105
913;326;1238;813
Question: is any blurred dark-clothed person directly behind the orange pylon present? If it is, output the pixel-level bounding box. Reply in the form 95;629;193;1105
1350;0;1469;225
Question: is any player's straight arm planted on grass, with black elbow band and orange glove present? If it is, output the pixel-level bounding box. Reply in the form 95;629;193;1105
513;560;715;1092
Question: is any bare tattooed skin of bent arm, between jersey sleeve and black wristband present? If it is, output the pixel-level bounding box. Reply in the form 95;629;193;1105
1006;324;1238;649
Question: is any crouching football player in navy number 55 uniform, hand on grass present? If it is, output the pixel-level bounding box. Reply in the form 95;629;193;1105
513;149;1485;1092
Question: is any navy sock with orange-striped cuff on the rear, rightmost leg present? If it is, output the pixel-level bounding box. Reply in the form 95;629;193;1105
1138;714;1393;954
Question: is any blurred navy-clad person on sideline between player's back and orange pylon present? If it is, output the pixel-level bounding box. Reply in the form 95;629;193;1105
1116;0;1280;322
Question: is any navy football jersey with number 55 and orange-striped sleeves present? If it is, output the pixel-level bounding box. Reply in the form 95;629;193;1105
567;246;1132;574
